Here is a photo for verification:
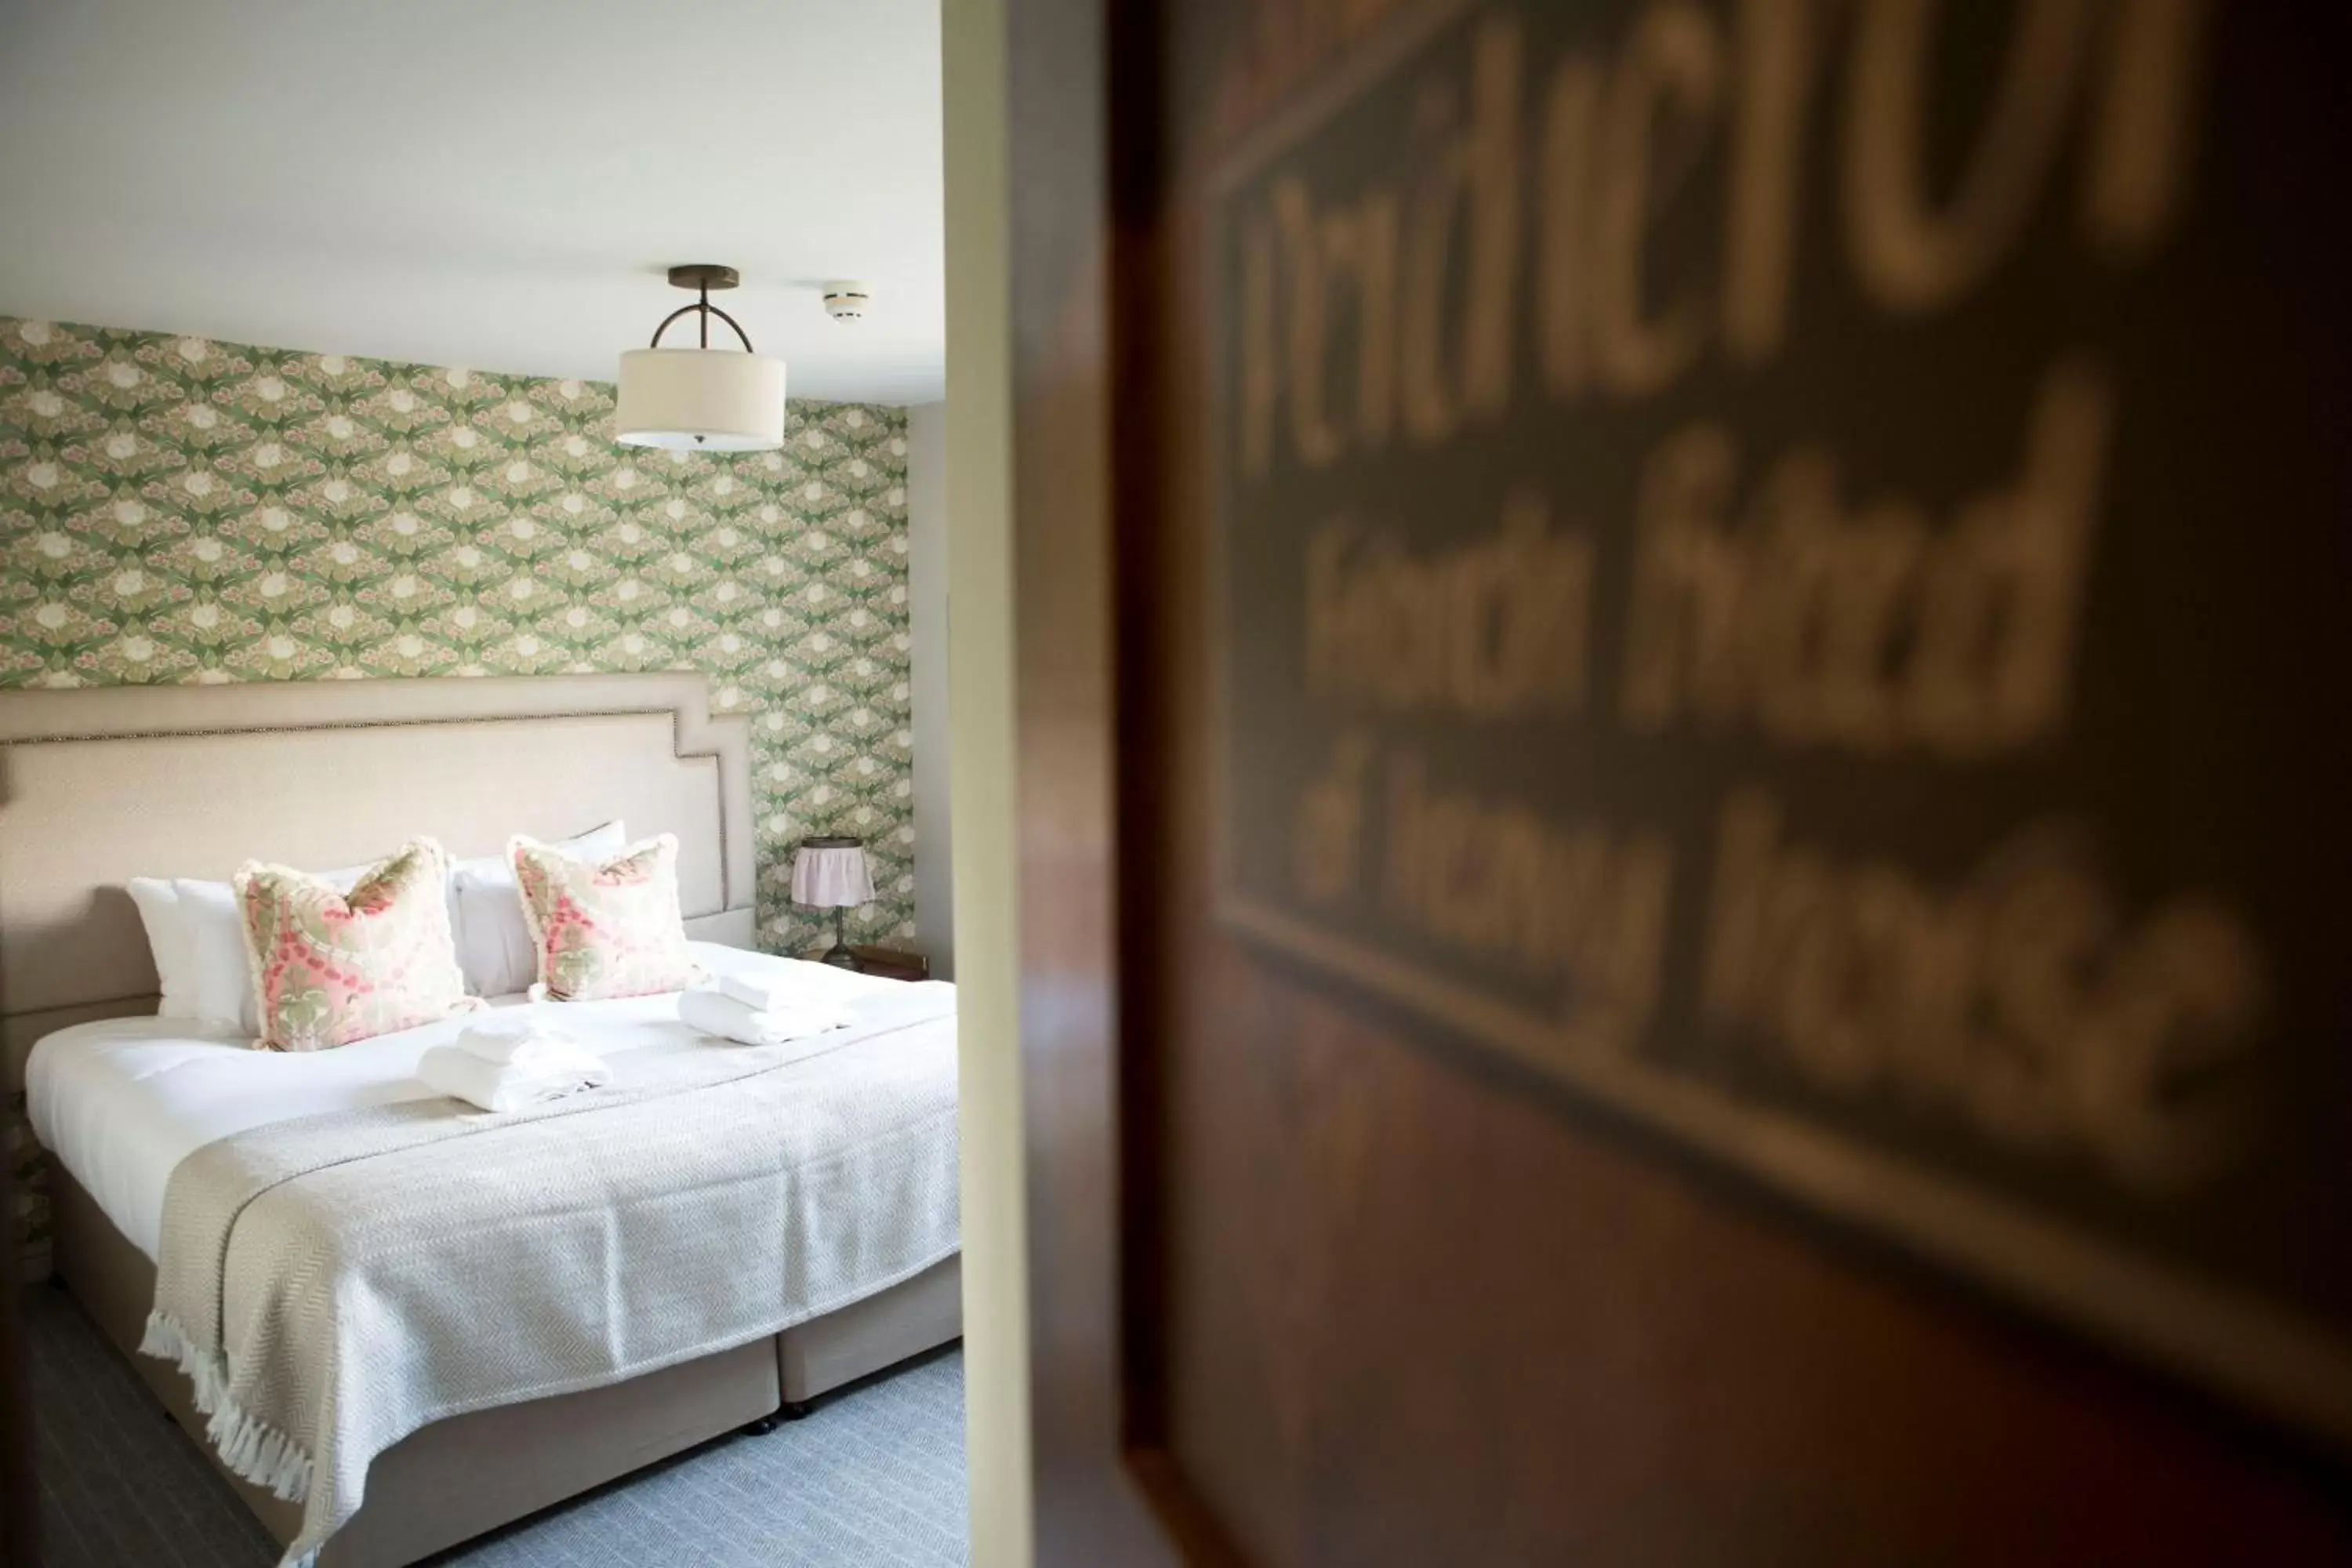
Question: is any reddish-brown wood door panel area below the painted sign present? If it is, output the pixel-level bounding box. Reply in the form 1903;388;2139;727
1169;945;2352;1568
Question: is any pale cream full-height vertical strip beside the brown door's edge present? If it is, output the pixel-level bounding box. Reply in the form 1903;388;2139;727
941;0;1035;1568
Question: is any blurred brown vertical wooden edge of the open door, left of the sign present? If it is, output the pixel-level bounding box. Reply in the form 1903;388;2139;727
1009;0;1237;1568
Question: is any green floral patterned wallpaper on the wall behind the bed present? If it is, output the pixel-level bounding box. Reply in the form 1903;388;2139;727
0;318;915;1279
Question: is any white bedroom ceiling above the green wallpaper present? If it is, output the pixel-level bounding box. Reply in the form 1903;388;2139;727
0;0;946;402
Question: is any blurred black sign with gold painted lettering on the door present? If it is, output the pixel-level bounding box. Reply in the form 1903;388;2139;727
1207;0;2352;1436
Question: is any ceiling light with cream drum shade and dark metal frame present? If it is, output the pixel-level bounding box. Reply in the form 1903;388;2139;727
614;263;783;452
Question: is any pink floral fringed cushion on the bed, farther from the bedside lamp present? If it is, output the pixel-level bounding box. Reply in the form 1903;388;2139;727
235;839;482;1051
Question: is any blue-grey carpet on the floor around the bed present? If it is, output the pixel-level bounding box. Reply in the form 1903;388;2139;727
26;1288;964;1568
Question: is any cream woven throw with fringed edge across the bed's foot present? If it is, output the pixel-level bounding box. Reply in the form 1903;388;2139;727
141;985;957;1568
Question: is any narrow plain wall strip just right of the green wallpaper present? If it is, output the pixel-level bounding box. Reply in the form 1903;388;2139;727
906;402;955;980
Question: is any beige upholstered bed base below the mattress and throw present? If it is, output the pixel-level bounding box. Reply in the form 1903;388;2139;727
49;1161;962;1568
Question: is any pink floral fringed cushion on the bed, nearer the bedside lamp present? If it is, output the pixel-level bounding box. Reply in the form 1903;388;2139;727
506;832;701;1001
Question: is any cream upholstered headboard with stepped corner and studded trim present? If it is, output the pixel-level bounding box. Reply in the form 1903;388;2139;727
0;673;755;1091
